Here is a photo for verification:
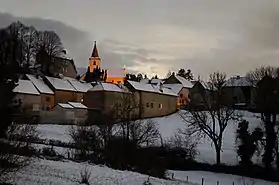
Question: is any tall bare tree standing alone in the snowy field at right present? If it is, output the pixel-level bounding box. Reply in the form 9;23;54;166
181;72;240;164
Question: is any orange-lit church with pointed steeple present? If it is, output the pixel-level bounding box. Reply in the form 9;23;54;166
80;41;126;84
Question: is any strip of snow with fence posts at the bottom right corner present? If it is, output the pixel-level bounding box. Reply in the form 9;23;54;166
169;170;278;185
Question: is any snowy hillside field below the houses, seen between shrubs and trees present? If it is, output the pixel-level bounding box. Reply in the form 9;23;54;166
37;111;260;165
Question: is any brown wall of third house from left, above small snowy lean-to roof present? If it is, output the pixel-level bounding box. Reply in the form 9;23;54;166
54;90;78;105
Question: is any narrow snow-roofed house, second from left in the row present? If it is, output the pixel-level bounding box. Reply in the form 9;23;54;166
26;74;54;110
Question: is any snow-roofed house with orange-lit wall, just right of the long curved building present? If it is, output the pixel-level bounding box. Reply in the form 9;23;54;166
164;74;193;108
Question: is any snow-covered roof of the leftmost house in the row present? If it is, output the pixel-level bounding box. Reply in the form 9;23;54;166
13;80;40;95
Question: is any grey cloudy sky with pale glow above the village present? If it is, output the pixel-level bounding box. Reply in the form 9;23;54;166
0;0;279;78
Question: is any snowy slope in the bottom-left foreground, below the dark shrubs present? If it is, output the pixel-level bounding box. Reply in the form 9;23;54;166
7;159;193;185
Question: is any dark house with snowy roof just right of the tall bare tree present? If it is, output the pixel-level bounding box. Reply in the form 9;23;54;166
222;76;256;108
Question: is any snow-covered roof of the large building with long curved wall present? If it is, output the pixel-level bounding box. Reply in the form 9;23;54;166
128;80;177;96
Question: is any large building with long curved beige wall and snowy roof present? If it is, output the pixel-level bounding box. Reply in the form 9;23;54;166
125;80;177;118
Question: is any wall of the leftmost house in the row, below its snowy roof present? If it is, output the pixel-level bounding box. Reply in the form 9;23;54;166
14;93;41;112
